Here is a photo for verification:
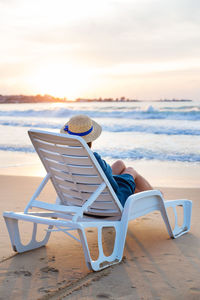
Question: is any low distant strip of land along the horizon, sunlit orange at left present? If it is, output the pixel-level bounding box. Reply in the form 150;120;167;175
0;95;192;104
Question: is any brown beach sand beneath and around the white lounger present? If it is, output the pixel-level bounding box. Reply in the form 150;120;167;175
0;175;200;300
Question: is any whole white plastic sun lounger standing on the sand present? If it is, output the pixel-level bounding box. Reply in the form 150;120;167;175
3;130;192;271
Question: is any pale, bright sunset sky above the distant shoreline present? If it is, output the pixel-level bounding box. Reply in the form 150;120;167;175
0;0;200;101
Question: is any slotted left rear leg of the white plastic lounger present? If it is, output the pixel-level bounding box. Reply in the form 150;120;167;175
4;217;53;252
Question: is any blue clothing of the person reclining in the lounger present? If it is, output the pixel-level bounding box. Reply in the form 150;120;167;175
94;152;136;206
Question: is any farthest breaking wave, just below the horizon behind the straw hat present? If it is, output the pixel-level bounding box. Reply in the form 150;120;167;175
0;106;200;121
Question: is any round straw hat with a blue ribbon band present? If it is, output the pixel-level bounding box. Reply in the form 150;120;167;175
60;115;102;143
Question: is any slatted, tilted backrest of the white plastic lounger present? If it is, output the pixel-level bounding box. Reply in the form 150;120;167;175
28;130;122;216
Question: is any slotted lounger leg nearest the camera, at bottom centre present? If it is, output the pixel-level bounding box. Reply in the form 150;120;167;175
78;225;123;271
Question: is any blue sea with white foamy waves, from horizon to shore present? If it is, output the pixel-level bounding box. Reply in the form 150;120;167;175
0;101;200;186
